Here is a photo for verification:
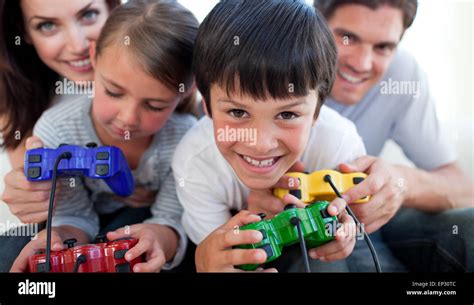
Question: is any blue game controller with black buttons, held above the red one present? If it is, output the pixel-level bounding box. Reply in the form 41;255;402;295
25;143;134;197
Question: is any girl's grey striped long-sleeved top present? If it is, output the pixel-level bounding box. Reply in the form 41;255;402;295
33;97;196;269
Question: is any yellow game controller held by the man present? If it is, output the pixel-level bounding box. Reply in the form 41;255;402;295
273;170;370;203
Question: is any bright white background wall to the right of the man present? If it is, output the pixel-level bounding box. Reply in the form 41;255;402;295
382;0;474;180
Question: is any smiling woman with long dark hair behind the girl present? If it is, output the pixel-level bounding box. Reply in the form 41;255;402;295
0;0;120;271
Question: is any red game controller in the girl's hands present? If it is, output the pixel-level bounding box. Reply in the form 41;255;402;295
28;237;144;272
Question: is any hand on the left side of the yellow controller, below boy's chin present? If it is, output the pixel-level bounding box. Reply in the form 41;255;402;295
247;161;304;219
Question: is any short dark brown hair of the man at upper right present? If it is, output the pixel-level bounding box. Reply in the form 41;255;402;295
314;0;418;30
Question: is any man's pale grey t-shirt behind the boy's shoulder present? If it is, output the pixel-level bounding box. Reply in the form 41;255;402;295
325;50;456;170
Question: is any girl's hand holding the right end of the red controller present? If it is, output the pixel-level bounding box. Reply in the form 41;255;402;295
107;224;179;272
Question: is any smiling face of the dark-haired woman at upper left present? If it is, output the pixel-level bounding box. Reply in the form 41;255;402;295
21;0;109;81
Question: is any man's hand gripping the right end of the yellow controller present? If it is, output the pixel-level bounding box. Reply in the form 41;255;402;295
339;156;407;234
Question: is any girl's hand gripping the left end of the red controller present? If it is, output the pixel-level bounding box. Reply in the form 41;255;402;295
10;228;63;272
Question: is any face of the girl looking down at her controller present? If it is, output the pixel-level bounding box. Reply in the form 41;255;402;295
92;46;181;145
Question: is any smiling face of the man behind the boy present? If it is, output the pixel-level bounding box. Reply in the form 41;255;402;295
328;4;403;105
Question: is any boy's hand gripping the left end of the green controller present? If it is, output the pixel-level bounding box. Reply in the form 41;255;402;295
196;211;276;272
